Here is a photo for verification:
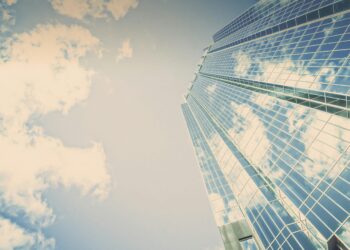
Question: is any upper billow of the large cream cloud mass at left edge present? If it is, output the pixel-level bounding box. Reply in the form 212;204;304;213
0;25;99;122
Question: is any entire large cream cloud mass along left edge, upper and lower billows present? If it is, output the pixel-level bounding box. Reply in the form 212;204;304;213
0;25;110;244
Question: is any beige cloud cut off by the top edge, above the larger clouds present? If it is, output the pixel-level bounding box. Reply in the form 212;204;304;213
51;0;138;20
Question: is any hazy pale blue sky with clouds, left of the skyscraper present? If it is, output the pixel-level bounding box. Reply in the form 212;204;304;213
0;0;255;250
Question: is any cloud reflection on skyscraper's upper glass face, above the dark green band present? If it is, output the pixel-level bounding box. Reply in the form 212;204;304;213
231;41;337;90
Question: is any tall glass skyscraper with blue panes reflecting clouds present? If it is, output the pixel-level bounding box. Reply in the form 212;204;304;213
182;0;350;250
